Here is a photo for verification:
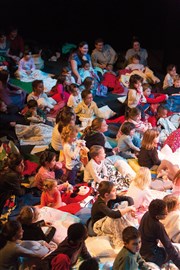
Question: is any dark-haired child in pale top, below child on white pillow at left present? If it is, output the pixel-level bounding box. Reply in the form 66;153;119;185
27;80;56;112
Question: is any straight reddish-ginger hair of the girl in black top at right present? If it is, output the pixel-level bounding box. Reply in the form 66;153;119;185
141;128;159;150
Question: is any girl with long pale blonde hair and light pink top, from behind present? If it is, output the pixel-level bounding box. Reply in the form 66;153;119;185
127;167;153;222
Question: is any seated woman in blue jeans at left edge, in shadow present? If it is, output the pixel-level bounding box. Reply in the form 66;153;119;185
0;70;27;110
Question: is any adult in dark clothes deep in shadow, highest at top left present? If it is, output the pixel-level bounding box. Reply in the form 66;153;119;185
7;25;24;64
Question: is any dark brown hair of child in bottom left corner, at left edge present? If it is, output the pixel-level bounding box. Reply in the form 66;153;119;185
0;220;21;249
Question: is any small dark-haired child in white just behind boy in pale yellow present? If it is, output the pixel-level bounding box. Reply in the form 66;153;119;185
67;83;82;109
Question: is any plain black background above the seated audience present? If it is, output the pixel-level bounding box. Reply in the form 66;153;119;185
0;0;180;72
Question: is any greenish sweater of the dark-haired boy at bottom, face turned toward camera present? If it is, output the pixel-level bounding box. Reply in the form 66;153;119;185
113;247;151;270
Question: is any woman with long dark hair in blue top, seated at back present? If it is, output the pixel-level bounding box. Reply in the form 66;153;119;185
69;41;92;84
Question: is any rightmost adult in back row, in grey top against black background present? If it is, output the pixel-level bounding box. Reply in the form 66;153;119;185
125;37;148;66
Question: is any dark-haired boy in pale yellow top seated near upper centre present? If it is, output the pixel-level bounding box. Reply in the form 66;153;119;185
74;90;103;125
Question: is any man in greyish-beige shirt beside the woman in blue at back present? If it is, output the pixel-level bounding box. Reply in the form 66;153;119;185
91;38;117;69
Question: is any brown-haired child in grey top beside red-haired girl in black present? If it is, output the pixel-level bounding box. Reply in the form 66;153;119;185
117;122;140;159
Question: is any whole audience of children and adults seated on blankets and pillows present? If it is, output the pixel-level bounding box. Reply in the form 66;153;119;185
0;27;180;270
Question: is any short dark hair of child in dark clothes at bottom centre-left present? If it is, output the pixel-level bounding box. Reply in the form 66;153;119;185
67;223;87;242
